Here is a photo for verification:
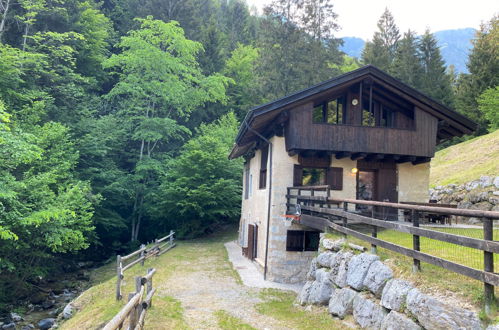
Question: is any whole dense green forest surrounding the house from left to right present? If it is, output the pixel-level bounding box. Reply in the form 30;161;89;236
0;0;499;310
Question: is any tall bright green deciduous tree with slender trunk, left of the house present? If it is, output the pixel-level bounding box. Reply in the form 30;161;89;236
104;17;229;241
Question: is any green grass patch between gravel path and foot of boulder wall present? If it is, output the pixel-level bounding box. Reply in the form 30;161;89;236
256;289;354;330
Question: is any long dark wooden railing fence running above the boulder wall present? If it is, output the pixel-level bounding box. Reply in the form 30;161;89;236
287;186;499;308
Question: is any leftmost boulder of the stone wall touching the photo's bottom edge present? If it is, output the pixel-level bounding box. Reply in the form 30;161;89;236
353;294;387;329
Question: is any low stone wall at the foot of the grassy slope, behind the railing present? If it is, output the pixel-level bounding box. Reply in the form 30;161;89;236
430;176;499;223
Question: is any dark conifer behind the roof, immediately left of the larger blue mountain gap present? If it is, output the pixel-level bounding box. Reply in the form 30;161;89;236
419;30;454;107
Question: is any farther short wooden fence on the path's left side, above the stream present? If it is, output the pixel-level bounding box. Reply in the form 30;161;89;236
116;230;175;300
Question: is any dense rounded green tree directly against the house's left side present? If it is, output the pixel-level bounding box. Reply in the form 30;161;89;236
155;114;242;237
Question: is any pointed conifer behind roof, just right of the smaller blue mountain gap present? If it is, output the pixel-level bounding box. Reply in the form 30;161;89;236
362;8;400;71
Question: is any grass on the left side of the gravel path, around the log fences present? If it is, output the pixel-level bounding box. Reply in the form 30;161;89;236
59;228;240;330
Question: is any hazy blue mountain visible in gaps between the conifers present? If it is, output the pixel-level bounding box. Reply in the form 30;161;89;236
340;28;476;73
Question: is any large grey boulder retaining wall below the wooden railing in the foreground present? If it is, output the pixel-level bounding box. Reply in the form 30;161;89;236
297;239;483;330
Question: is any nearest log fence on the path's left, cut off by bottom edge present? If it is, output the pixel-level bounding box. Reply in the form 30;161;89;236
104;268;156;330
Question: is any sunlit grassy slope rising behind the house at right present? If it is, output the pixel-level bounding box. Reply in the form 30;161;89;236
430;130;499;187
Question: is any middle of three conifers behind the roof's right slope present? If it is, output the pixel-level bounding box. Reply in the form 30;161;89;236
389;30;423;89
